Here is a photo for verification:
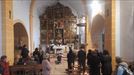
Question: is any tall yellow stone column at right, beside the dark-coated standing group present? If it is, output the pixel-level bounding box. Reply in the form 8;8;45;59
105;0;115;69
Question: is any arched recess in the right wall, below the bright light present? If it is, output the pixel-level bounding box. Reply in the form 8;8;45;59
91;14;105;51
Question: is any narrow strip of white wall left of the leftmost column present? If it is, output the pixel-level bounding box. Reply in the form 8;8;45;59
0;1;2;56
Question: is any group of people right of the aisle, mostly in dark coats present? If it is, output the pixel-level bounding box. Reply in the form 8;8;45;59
67;47;134;75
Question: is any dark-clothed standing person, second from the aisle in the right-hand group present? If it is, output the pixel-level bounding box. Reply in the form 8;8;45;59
78;46;86;74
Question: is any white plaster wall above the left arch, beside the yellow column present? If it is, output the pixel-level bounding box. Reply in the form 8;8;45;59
13;0;31;48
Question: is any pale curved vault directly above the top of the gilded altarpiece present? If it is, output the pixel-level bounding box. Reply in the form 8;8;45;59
35;0;89;16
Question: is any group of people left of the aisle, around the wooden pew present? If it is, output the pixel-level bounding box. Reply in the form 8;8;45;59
0;45;51;75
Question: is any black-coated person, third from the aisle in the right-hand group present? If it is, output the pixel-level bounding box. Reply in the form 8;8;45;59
89;51;100;75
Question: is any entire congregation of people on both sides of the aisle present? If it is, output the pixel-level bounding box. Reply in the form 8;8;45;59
0;45;134;75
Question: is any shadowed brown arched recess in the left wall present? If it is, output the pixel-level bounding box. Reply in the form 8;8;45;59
13;22;29;62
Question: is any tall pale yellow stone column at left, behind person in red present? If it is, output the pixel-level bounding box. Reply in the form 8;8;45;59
2;0;14;65
